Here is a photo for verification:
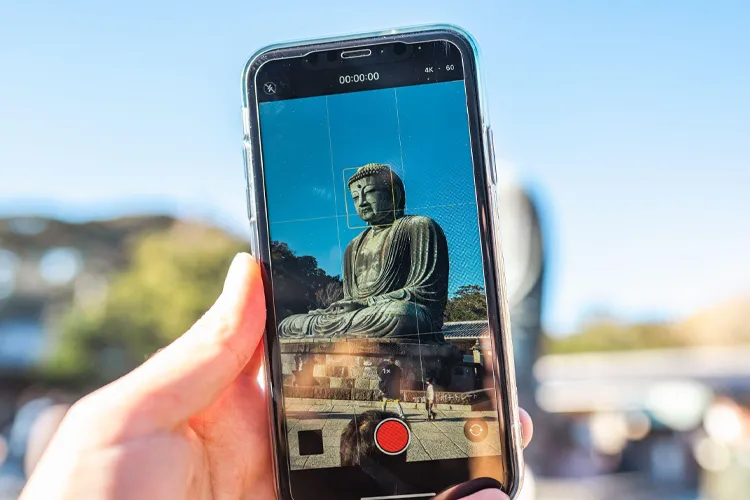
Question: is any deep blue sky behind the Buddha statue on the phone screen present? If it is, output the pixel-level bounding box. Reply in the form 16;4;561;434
260;81;484;293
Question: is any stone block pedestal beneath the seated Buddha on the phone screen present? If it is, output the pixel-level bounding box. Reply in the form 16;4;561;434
280;338;463;401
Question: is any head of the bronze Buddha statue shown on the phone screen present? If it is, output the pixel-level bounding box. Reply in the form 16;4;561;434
348;163;406;226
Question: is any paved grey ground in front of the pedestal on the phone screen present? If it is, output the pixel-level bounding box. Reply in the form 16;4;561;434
286;398;500;469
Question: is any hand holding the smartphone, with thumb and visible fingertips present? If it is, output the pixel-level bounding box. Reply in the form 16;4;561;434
20;254;532;500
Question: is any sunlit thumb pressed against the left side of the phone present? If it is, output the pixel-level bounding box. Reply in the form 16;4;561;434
84;253;266;441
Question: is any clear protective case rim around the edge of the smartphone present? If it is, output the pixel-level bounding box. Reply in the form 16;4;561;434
242;24;524;498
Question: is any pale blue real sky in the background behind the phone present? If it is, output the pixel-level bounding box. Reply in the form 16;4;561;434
0;0;750;332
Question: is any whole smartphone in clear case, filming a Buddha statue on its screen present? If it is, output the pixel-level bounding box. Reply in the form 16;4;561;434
242;26;523;500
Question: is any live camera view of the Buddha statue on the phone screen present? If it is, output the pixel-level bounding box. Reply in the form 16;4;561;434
259;42;501;492
